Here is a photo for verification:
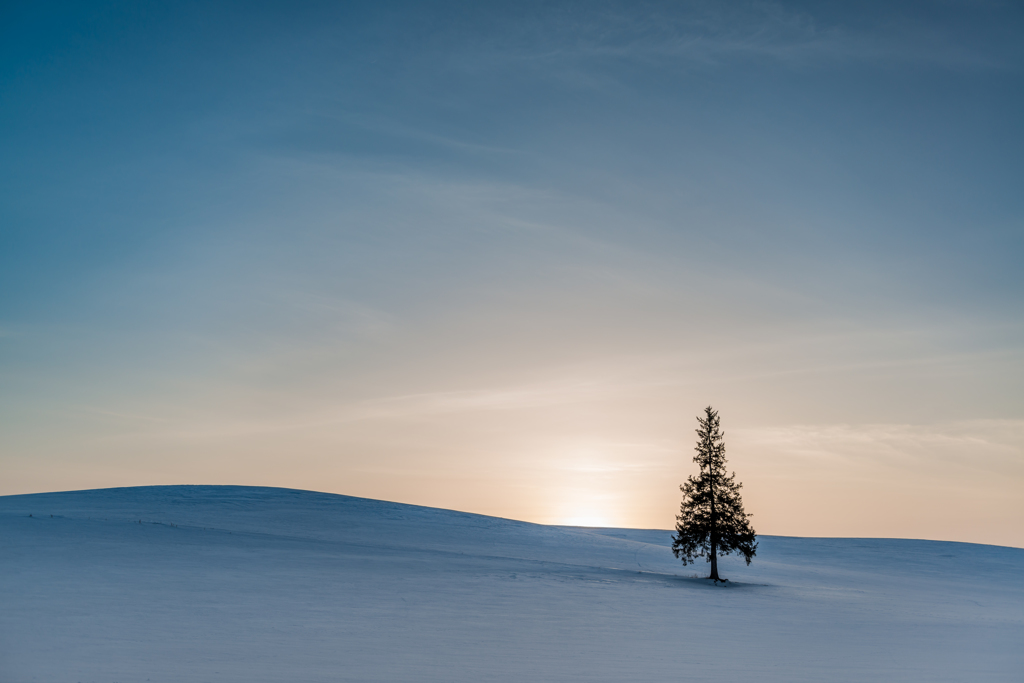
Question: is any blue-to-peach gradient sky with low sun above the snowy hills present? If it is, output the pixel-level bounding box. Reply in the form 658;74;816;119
0;0;1024;546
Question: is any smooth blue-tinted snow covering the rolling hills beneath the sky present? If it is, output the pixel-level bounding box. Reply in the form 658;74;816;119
0;486;1024;683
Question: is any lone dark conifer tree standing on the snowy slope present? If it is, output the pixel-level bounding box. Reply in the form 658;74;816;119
672;405;758;582
